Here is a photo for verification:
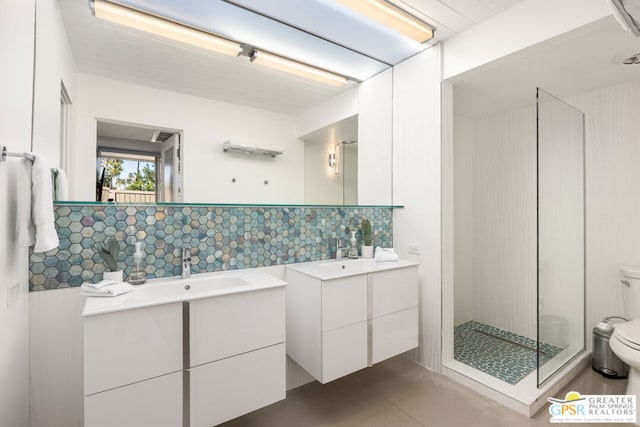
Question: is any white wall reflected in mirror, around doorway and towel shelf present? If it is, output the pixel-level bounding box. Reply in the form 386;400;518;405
71;74;304;203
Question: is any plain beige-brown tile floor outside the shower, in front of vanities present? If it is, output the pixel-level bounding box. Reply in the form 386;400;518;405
223;356;627;427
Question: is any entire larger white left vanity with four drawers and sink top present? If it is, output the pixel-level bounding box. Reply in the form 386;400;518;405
83;270;286;427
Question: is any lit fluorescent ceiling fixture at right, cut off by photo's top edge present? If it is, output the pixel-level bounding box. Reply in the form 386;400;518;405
337;0;433;43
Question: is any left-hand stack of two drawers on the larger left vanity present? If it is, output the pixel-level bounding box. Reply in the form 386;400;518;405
84;302;183;427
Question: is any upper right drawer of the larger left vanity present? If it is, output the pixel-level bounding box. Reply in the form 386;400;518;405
189;287;286;366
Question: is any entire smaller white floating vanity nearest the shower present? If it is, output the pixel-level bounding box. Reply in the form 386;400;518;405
286;259;418;384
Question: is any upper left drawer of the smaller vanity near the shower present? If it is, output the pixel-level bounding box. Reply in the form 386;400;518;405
322;275;367;331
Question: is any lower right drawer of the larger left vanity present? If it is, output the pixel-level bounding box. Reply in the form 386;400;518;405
188;344;286;427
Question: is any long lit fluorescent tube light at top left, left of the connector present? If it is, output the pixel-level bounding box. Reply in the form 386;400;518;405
92;0;241;56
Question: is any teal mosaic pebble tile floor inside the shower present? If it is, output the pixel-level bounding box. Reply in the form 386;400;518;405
454;320;562;384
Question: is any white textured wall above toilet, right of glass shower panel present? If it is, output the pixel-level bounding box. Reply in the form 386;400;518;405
566;81;640;349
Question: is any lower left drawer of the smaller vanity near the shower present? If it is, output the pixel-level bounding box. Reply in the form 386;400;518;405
320;320;367;384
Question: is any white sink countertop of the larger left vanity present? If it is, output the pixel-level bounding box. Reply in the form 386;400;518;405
82;269;287;316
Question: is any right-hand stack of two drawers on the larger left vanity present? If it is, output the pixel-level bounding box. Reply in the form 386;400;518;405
187;288;286;427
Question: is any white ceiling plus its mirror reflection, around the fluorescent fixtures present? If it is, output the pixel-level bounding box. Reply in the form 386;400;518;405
59;0;522;115
